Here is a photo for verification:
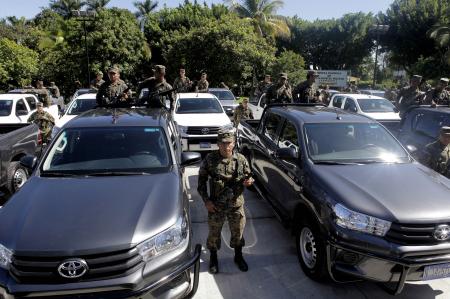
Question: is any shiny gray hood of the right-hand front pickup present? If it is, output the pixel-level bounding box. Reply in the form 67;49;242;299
314;162;450;223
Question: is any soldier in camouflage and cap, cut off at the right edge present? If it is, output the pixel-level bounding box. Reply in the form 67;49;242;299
421;127;450;178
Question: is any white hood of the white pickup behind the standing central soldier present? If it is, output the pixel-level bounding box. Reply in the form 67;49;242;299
174;113;231;127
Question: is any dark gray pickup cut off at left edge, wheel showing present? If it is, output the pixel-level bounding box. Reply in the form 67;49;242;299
0;123;41;193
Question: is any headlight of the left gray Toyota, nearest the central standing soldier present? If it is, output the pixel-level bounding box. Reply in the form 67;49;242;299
137;214;188;262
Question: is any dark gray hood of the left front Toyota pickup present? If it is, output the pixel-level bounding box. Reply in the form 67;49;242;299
0;172;182;255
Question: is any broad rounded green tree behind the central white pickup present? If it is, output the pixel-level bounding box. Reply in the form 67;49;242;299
163;16;275;86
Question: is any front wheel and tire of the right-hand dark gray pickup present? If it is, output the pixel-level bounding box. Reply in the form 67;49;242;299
295;221;329;281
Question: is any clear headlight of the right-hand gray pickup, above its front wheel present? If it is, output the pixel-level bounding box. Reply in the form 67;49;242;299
333;204;391;237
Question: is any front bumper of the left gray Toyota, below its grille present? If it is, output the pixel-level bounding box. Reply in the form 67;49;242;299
0;244;201;299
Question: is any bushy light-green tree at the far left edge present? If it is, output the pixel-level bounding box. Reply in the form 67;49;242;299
0;38;38;90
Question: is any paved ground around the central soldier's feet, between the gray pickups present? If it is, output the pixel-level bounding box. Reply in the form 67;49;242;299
187;167;450;299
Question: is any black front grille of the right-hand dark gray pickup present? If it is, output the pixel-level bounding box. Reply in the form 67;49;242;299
386;223;450;245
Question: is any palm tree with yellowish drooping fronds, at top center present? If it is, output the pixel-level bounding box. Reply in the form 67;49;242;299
228;0;290;37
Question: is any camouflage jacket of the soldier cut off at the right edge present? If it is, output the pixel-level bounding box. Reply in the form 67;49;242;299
422;140;450;178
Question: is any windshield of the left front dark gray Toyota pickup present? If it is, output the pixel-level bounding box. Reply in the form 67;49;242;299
42;127;171;175
